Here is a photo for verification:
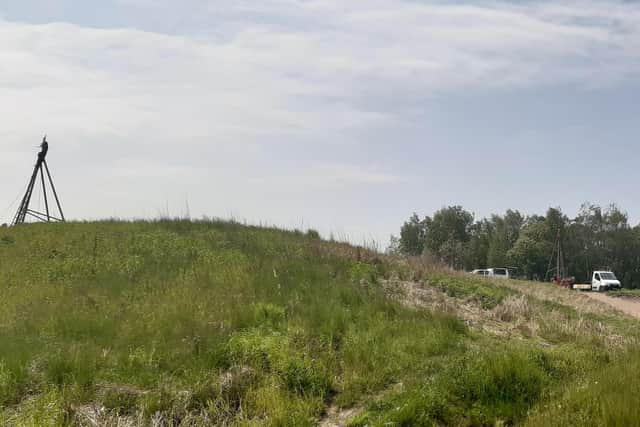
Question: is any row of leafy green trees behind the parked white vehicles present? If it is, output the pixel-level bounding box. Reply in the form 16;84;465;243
389;203;640;287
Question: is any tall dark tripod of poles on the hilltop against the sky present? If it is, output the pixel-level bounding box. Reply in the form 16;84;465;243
11;136;64;225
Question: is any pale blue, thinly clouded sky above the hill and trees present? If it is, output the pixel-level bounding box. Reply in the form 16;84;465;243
0;0;640;247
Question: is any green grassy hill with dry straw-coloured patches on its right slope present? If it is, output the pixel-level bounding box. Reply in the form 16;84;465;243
0;221;640;426
